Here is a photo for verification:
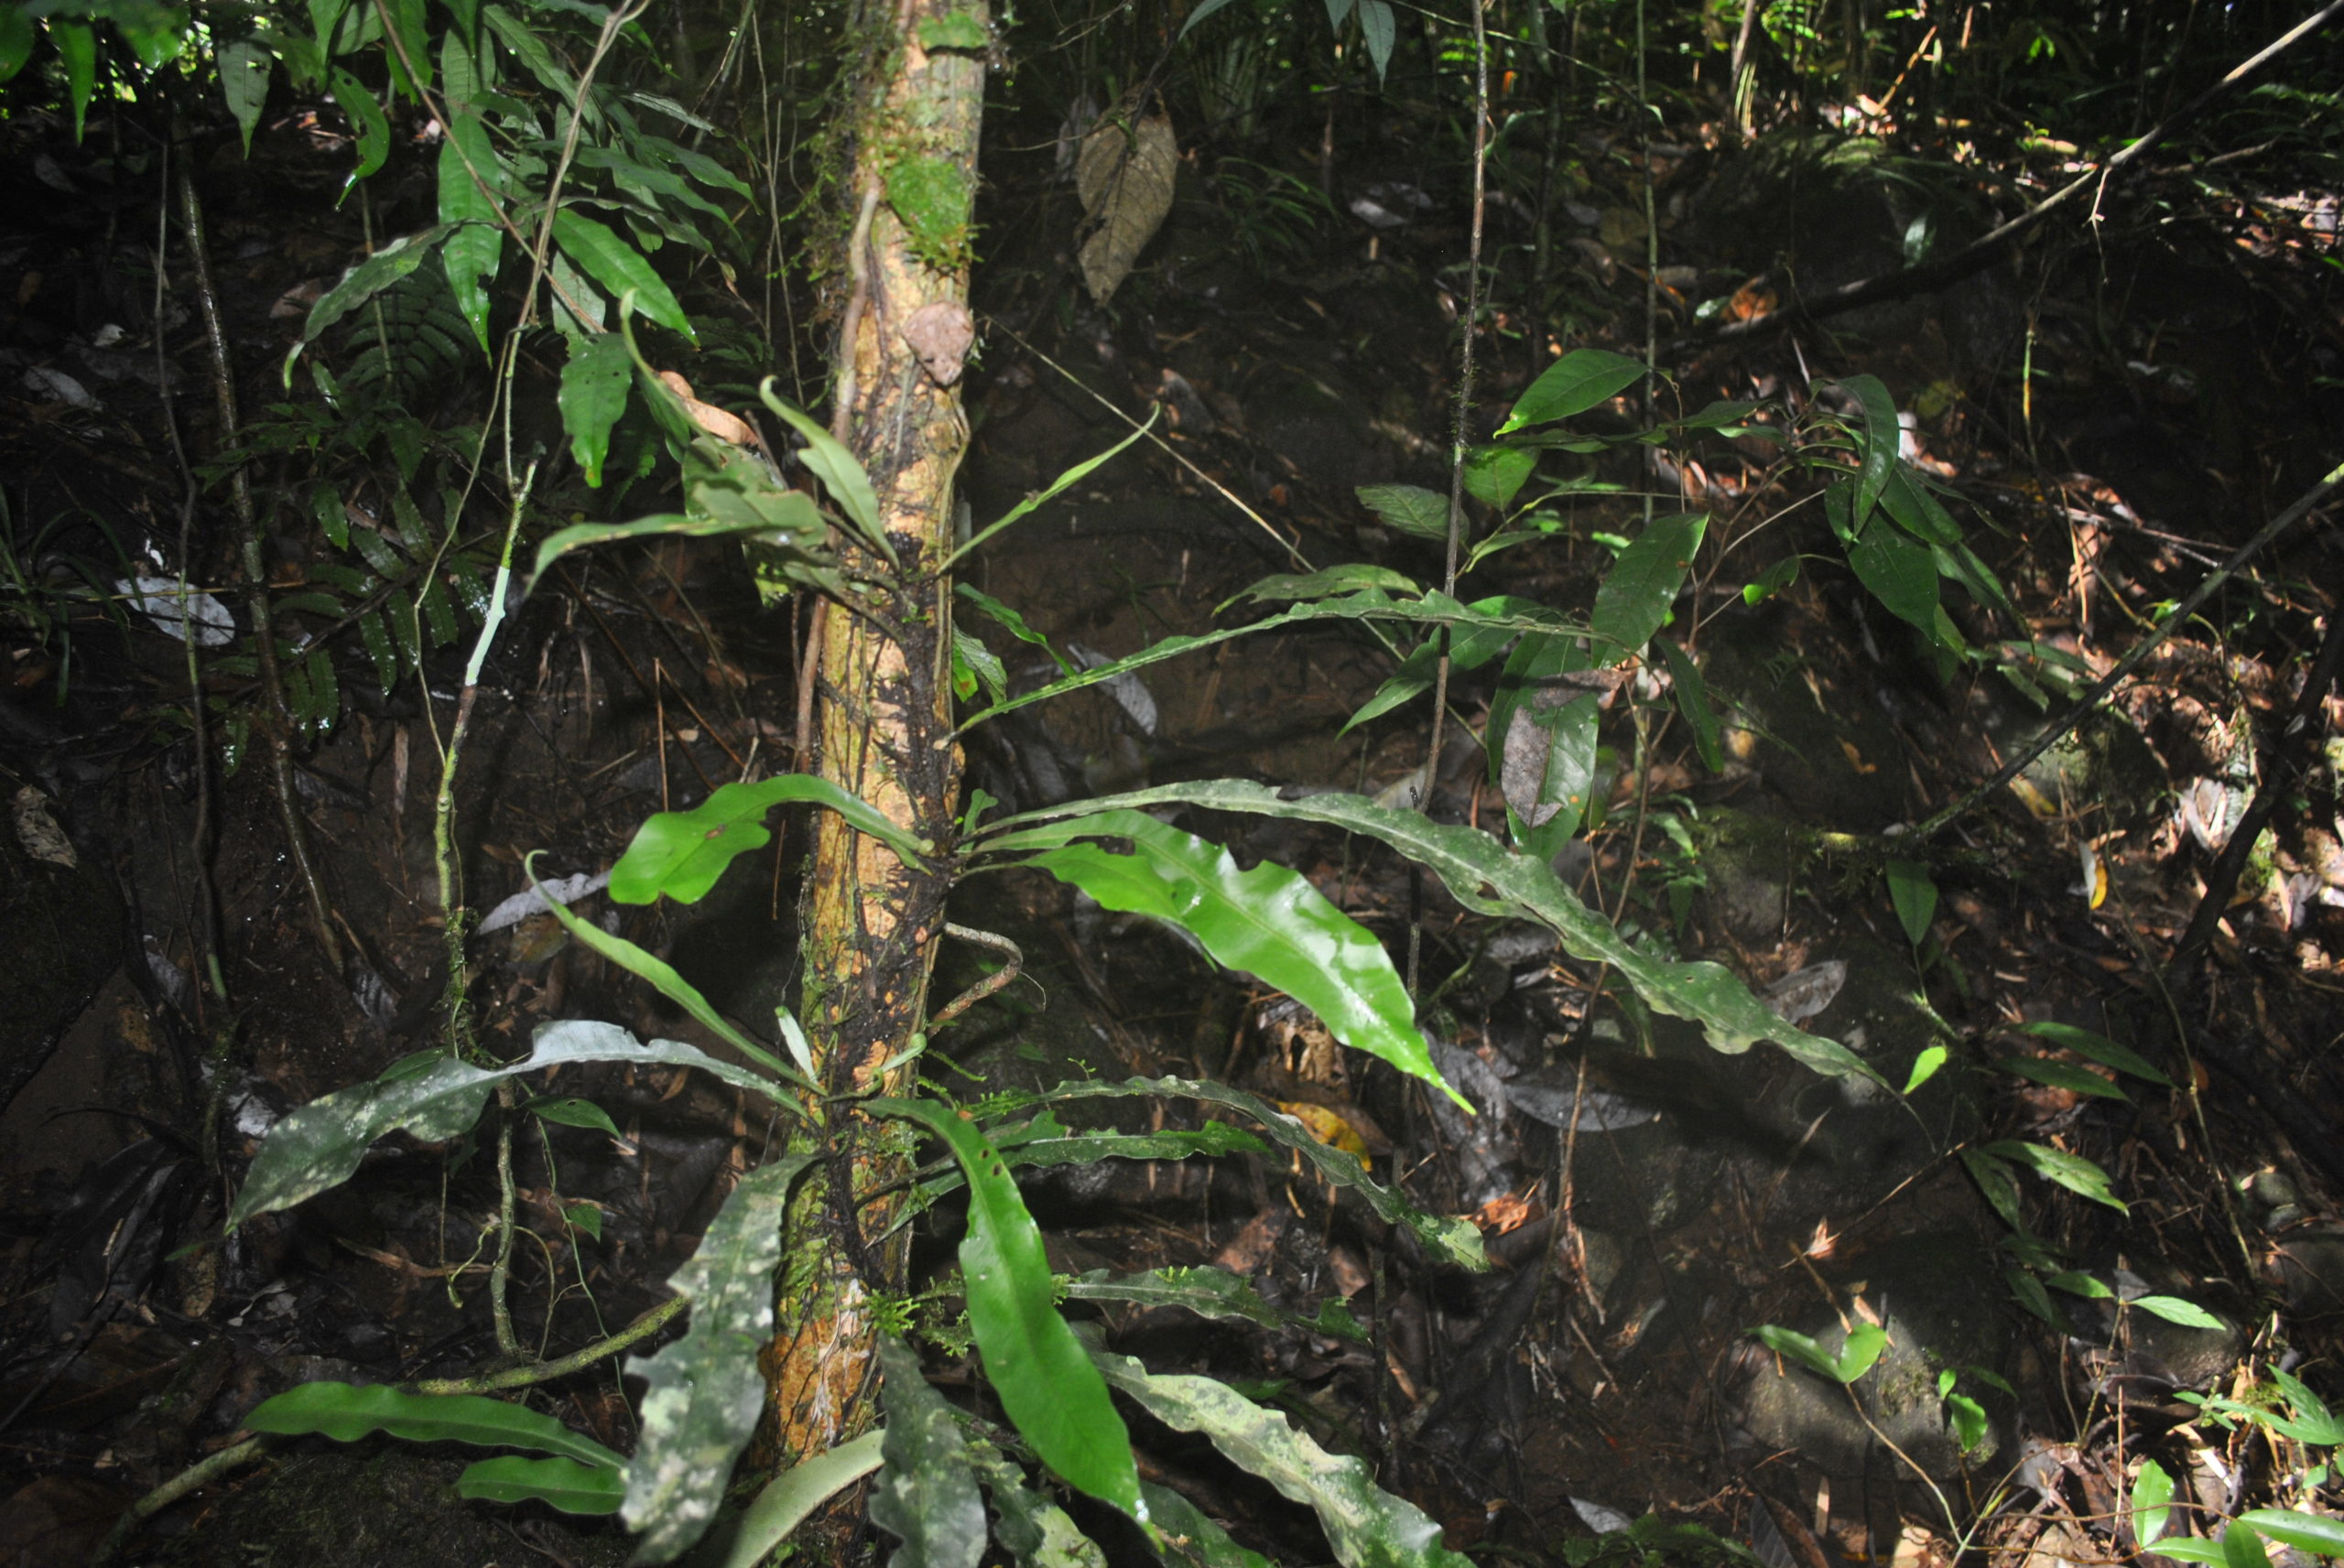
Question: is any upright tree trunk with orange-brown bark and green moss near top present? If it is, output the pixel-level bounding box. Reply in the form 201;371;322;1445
759;0;984;1544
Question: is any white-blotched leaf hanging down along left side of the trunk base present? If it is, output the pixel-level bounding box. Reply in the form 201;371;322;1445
621;1151;813;1563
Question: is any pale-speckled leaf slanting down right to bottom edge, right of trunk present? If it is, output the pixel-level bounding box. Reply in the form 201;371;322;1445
1092;1350;1472;1568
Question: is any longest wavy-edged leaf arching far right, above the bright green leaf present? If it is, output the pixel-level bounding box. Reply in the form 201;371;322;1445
987;778;1889;1087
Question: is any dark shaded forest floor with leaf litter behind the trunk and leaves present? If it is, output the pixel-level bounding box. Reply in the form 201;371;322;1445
0;80;2344;1568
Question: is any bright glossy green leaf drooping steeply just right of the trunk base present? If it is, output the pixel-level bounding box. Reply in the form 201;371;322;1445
865;1099;1139;1514
